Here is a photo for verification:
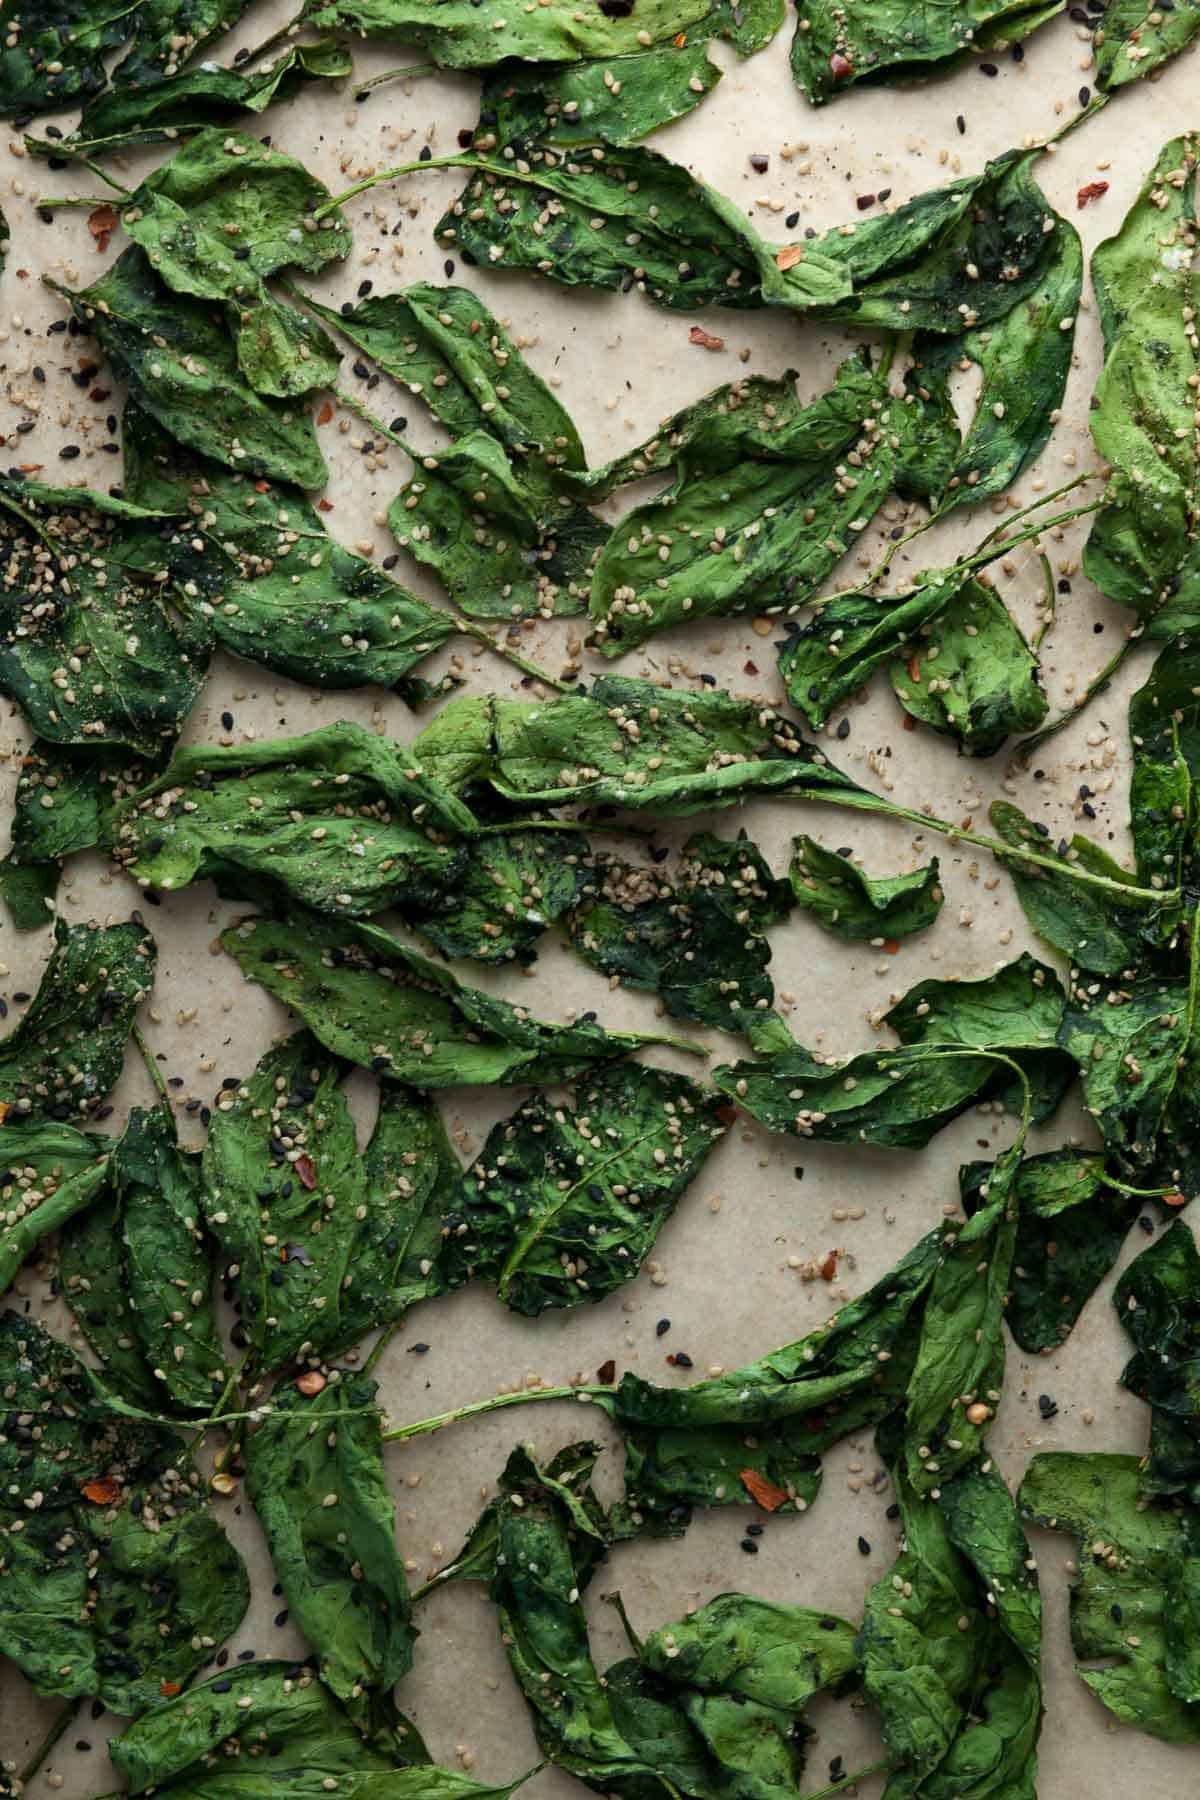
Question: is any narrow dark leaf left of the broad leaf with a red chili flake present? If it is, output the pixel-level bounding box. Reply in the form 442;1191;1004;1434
61;1107;227;1415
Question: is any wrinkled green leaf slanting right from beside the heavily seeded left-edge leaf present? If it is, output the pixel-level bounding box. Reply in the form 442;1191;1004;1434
121;400;455;688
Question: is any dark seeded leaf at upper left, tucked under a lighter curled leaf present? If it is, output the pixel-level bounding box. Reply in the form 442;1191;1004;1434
58;245;327;488
